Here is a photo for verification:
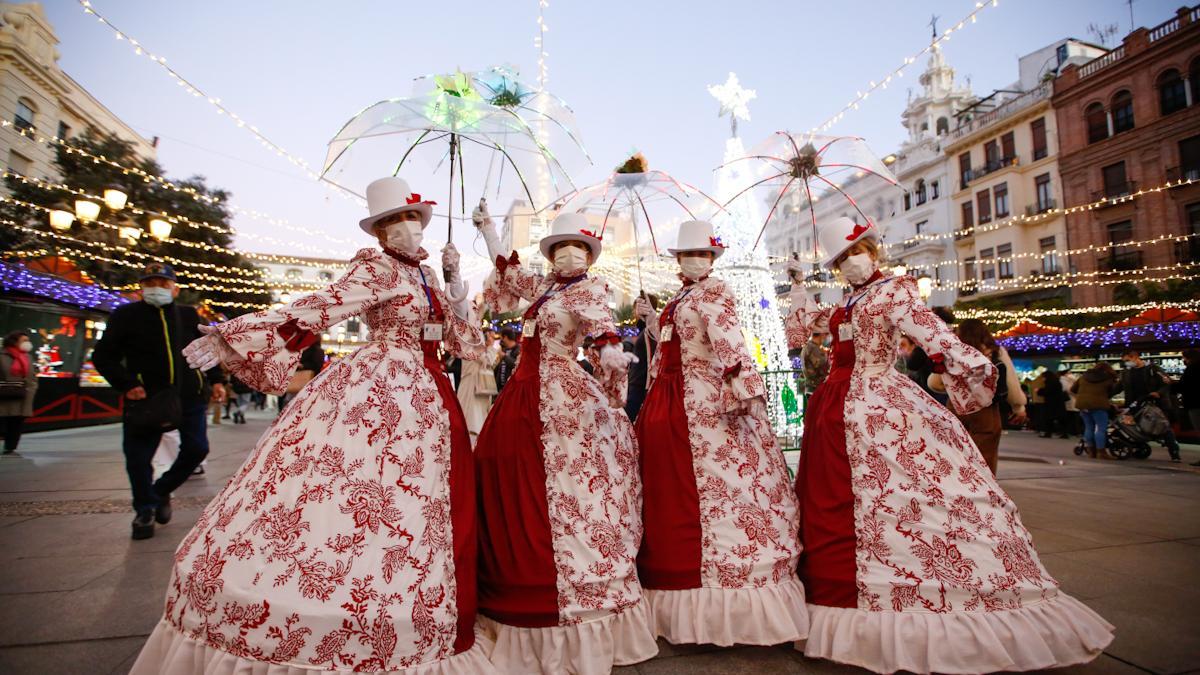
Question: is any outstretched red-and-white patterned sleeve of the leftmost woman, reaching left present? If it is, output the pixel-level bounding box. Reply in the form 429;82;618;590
217;249;401;393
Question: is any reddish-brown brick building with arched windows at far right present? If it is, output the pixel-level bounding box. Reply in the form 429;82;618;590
1052;7;1200;306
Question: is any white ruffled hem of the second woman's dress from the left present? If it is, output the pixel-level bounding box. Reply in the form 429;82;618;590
479;598;659;675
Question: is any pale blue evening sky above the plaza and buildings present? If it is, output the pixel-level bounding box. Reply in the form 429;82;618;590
46;0;1182;263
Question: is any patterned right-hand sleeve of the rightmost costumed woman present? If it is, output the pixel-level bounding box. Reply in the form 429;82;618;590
872;276;997;414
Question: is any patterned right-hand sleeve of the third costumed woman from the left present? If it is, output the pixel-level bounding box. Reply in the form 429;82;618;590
696;281;767;412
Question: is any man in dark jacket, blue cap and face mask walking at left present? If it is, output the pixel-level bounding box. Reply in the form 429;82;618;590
92;263;224;539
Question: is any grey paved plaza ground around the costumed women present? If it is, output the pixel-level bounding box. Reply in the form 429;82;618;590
0;413;1200;675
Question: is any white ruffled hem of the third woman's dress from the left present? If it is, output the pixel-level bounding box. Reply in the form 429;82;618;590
643;571;809;647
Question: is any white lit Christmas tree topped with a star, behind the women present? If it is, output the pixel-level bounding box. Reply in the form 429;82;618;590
708;73;802;438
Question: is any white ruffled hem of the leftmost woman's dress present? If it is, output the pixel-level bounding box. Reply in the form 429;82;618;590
123;619;499;675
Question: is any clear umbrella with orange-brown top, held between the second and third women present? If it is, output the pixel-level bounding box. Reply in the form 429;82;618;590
554;154;724;293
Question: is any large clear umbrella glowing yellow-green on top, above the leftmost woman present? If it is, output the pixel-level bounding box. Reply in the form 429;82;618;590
322;73;572;257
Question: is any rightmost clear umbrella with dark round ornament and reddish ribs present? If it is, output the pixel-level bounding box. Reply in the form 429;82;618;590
724;131;900;257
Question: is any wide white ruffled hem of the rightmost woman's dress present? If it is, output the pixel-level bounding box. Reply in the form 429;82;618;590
797;593;1114;673
